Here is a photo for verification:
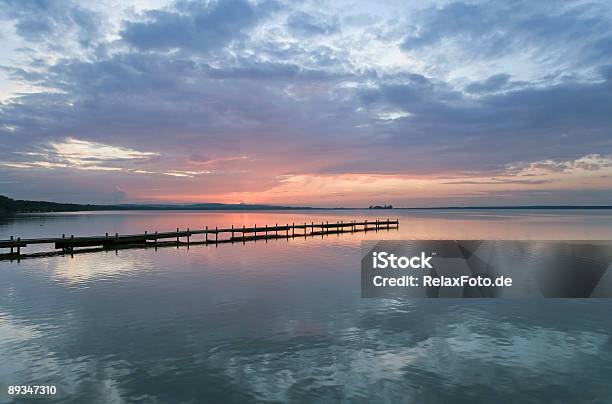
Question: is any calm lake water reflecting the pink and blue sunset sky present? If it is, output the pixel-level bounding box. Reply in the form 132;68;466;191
0;210;612;403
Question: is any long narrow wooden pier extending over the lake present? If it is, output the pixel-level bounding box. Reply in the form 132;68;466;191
0;219;399;261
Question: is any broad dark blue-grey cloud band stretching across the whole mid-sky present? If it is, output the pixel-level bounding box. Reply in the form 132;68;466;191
0;47;612;180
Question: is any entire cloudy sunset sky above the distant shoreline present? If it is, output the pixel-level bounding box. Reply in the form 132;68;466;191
0;0;612;207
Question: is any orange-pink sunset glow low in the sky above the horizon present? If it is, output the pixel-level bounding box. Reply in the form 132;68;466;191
131;159;612;207
